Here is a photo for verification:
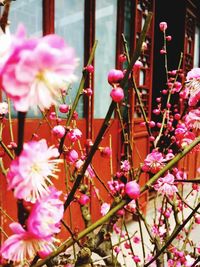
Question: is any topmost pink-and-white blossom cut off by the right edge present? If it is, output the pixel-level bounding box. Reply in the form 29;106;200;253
181;68;200;106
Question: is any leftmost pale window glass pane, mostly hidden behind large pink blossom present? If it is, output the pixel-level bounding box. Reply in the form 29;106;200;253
3;0;43;117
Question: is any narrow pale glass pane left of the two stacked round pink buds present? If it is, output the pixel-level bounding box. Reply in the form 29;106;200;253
94;0;117;118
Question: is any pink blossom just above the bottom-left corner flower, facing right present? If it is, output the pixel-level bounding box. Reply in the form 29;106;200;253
27;187;64;238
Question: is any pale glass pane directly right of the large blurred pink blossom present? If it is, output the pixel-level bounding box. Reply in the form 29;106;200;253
55;0;84;117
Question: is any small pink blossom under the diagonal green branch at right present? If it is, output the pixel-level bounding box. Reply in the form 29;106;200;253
154;173;178;196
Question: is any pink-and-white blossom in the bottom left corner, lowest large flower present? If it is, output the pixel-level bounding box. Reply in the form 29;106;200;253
0;222;55;266
